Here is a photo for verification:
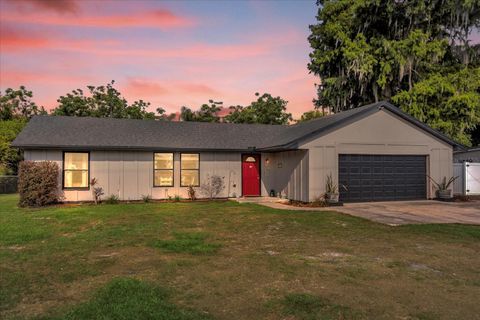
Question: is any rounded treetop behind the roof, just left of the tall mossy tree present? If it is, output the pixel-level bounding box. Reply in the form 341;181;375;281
225;92;292;124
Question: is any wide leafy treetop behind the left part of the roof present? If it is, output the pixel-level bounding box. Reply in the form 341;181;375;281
52;80;161;119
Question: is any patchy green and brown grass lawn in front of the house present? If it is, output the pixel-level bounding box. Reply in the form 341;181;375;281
0;195;480;320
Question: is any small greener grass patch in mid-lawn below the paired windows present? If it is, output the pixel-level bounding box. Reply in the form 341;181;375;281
152;232;222;254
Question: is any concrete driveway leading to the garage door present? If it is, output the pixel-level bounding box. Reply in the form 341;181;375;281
328;200;480;225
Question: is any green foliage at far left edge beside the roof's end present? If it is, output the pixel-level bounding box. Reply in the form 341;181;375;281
0;118;26;175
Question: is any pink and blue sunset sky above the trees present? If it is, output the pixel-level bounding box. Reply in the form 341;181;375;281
0;0;319;117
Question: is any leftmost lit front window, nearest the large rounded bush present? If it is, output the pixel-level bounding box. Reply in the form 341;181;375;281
63;152;89;189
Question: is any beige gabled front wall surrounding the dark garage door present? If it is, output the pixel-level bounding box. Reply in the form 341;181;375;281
299;110;453;201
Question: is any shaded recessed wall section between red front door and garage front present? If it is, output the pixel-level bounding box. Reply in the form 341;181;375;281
261;150;309;202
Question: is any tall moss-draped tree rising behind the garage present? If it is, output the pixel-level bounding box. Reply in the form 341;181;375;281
308;0;480;143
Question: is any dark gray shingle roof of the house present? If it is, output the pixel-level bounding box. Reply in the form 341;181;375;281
12;102;458;151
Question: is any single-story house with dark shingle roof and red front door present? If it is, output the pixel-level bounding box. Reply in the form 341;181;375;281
13;102;460;202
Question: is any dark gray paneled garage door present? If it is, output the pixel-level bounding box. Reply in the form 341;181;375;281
338;154;427;202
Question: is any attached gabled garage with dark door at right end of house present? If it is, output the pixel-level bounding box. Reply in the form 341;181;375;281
298;103;461;202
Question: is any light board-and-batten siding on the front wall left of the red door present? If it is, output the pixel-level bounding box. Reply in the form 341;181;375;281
24;150;242;201
